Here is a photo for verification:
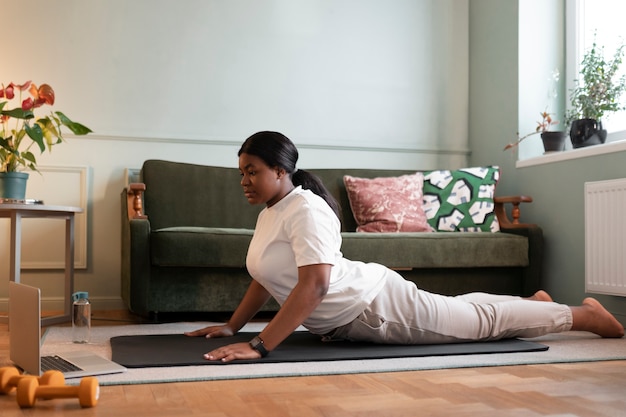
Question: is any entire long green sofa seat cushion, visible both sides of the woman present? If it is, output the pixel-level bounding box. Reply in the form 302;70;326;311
150;227;529;268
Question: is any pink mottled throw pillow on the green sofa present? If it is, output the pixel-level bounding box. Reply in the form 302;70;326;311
343;172;432;232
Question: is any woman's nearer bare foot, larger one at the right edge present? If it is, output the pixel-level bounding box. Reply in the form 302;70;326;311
571;297;624;337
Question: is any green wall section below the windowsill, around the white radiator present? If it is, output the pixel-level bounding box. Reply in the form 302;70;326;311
519;151;626;323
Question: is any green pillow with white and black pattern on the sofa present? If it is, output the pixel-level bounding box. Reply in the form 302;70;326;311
424;166;500;232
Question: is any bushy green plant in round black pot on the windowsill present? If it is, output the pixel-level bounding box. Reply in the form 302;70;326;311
566;37;626;148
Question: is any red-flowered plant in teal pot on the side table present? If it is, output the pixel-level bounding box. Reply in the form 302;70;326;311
0;81;91;200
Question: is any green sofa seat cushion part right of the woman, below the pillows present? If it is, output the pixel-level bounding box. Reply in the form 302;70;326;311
341;232;529;268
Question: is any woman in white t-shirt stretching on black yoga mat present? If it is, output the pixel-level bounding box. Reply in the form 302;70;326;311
187;132;624;362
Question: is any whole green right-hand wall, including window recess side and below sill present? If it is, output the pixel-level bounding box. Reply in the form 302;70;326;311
469;0;626;323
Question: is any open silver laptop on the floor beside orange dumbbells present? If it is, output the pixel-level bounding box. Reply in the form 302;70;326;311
9;281;126;378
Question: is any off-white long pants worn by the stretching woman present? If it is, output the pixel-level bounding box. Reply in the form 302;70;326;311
326;271;572;344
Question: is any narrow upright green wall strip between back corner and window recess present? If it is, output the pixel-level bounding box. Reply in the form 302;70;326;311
469;0;519;184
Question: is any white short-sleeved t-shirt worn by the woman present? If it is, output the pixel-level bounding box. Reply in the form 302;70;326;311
246;187;387;334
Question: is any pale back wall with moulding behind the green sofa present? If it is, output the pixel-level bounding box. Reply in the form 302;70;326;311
0;0;469;310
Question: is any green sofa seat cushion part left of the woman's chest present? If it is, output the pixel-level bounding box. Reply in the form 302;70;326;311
150;227;254;268
